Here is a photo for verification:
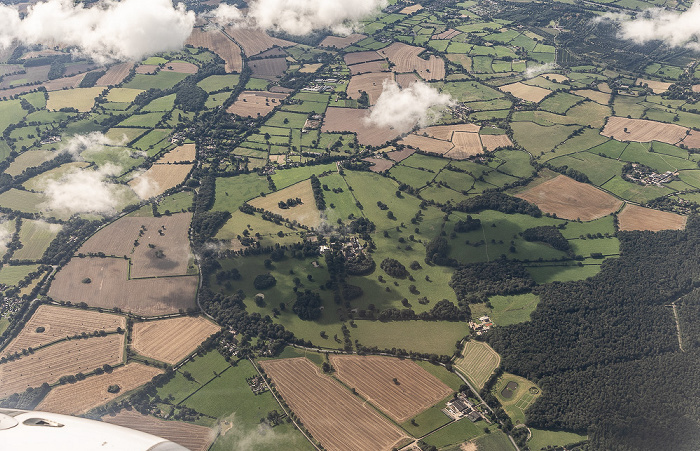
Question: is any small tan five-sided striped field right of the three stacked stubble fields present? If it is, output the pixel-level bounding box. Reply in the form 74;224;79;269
131;316;220;365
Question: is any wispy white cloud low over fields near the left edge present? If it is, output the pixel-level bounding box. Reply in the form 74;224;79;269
42;165;133;215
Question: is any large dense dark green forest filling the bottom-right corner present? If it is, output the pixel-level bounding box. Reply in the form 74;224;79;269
487;216;700;450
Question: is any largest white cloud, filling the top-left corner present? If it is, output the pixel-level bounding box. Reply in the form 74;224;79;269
0;0;195;63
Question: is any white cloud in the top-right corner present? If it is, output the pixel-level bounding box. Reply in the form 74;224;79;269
605;2;700;50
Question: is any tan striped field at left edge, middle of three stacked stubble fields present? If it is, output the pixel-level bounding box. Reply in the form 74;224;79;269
0;334;124;398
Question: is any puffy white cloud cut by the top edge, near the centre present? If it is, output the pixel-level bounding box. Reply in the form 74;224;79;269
208;0;387;36
